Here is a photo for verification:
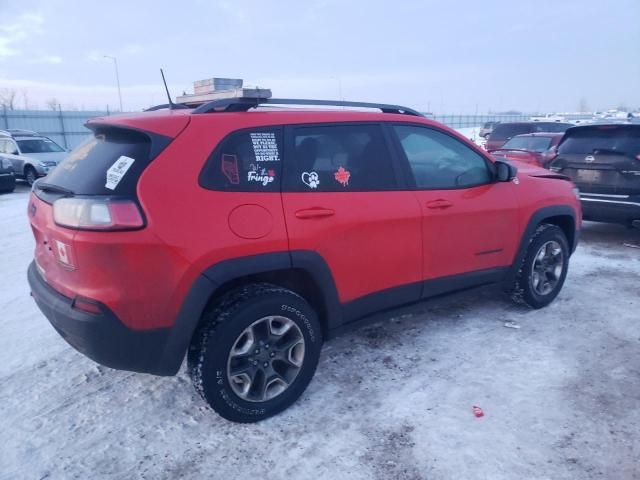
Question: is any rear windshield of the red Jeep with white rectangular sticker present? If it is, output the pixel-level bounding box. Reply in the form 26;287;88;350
41;127;159;196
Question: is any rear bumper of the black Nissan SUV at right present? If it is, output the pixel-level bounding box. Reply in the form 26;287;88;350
580;192;640;224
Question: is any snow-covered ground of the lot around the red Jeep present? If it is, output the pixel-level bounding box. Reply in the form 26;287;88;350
0;187;640;480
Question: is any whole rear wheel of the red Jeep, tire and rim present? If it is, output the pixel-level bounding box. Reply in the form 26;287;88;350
188;284;322;423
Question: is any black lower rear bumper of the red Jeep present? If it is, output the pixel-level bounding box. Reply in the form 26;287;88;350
27;262;178;375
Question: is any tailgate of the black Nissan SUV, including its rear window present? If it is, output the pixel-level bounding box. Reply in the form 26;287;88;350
550;125;640;195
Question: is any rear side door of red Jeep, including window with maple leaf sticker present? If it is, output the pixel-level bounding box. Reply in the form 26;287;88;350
282;123;422;317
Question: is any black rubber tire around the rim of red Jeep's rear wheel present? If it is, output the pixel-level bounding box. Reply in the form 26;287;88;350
187;283;322;423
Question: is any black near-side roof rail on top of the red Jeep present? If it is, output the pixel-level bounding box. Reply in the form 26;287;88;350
193;97;424;117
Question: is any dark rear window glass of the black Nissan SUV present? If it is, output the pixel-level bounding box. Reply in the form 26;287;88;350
558;125;640;157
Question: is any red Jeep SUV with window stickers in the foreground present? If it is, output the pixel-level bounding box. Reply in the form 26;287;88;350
28;98;581;422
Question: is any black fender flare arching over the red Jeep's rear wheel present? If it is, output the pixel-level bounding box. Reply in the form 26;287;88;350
152;250;341;375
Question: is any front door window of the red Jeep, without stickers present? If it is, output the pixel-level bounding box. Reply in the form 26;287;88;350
393;125;492;190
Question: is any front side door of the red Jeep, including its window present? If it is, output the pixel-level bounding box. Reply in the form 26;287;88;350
392;124;519;284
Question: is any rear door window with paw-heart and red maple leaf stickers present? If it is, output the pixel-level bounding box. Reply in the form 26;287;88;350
287;124;397;192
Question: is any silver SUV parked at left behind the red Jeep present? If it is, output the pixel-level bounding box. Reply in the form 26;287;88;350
0;130;67;185
